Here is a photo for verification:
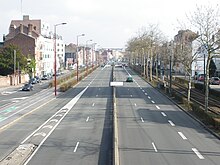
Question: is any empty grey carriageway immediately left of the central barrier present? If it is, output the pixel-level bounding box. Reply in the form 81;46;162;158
24;68;112;165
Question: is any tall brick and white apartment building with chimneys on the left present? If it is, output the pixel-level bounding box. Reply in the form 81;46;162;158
4;15;65;76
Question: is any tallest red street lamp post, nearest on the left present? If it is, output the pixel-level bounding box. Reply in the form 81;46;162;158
54;23;66;96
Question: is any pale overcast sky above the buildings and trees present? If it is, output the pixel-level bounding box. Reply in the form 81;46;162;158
0;0;219;48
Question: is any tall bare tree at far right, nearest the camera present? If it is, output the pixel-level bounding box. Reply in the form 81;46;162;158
188;6;220;111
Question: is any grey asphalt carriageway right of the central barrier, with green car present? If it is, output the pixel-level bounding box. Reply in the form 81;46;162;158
115;68;220;165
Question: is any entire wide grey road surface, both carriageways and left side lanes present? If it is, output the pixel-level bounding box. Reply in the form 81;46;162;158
0;66;220;165
